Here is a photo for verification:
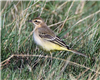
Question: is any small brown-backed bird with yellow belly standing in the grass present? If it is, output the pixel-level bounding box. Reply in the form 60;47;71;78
29;17;87;57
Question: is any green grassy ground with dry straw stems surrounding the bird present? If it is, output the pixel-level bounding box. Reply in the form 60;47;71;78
0;0;100;80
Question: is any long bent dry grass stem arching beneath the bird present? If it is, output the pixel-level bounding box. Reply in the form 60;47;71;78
0;54;100;74
